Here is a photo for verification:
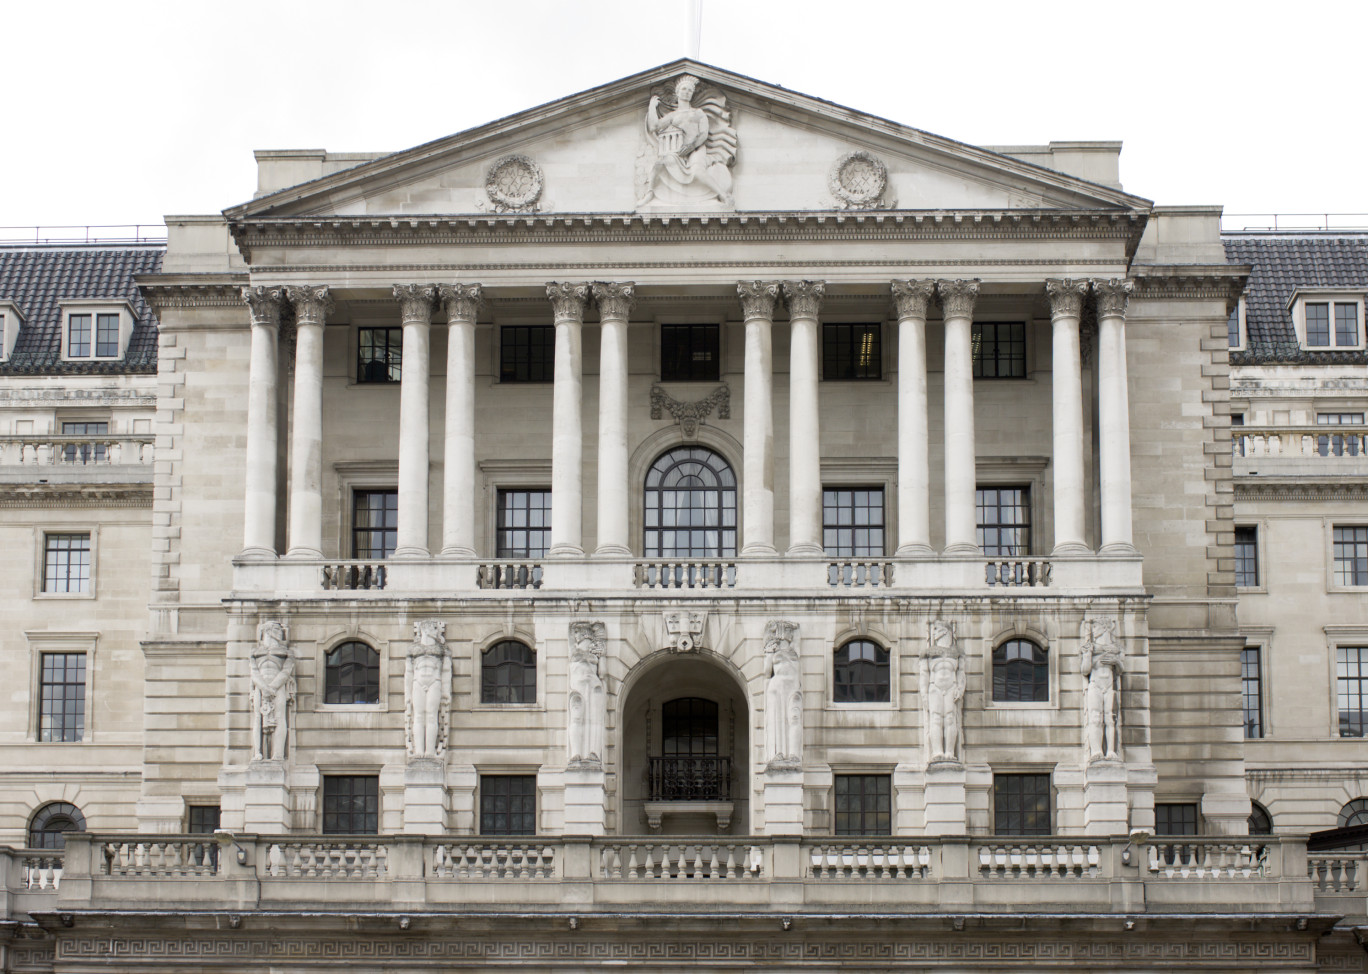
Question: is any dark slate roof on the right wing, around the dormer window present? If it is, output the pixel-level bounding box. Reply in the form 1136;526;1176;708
1222;230;1368;365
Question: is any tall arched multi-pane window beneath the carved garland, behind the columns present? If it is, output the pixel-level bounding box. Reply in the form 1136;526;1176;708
643;446;736;558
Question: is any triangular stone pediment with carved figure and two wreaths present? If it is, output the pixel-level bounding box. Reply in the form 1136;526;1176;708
226;60;1149;220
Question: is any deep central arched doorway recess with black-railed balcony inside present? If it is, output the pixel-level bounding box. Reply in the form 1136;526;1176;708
620;653;750;836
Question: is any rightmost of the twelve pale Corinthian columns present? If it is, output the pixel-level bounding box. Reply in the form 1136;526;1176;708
1093;280;1135;554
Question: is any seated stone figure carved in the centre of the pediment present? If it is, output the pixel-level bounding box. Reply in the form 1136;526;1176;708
636;74;736;209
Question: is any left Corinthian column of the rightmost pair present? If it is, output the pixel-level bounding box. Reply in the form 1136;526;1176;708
1045;280;1088;554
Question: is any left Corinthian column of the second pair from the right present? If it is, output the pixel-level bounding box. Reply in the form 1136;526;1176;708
892;280;936;557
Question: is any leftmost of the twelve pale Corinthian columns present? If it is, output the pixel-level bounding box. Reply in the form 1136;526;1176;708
242;285;285;558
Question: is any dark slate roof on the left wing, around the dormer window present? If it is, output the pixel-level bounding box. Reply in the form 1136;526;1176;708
0;244;166;375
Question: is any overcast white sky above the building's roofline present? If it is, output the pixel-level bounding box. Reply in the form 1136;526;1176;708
0;0;1368;237
